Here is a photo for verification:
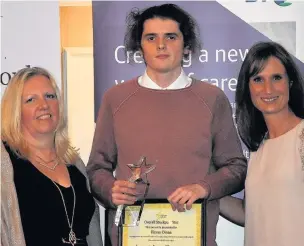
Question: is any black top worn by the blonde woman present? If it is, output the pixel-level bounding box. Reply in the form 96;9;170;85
5;145;95;246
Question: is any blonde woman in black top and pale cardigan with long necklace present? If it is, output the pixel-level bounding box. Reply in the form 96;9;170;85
1;67;102;246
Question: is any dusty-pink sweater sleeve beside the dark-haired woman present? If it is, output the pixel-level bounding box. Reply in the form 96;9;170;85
201;91;247;199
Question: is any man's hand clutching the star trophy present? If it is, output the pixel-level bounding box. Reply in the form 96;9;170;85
112;180;138;206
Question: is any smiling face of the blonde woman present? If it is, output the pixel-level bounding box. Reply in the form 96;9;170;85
21;75;59;138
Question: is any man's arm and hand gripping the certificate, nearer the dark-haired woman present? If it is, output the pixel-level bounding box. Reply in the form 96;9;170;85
168;91;247;212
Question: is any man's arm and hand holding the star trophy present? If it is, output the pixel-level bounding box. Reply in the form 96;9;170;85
87;93;138;208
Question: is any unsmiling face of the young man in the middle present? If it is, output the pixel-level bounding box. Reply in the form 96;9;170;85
141;18;189;75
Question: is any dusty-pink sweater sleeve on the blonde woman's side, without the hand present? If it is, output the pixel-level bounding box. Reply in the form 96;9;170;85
87;93;117;208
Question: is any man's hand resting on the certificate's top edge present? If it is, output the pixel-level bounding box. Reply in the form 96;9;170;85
168;184;208;212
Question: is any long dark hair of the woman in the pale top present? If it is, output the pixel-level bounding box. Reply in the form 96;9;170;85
236;42;304;151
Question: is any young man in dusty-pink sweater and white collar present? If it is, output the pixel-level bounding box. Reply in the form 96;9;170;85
88;4;247;246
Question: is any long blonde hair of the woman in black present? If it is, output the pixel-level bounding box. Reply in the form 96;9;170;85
1;67;79;163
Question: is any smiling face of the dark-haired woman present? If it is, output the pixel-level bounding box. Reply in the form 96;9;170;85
249;57;289;117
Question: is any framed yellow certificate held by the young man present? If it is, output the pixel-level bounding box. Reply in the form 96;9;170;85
119;199;206;246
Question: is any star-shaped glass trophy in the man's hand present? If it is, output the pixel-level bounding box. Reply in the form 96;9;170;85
114;156;156;226
